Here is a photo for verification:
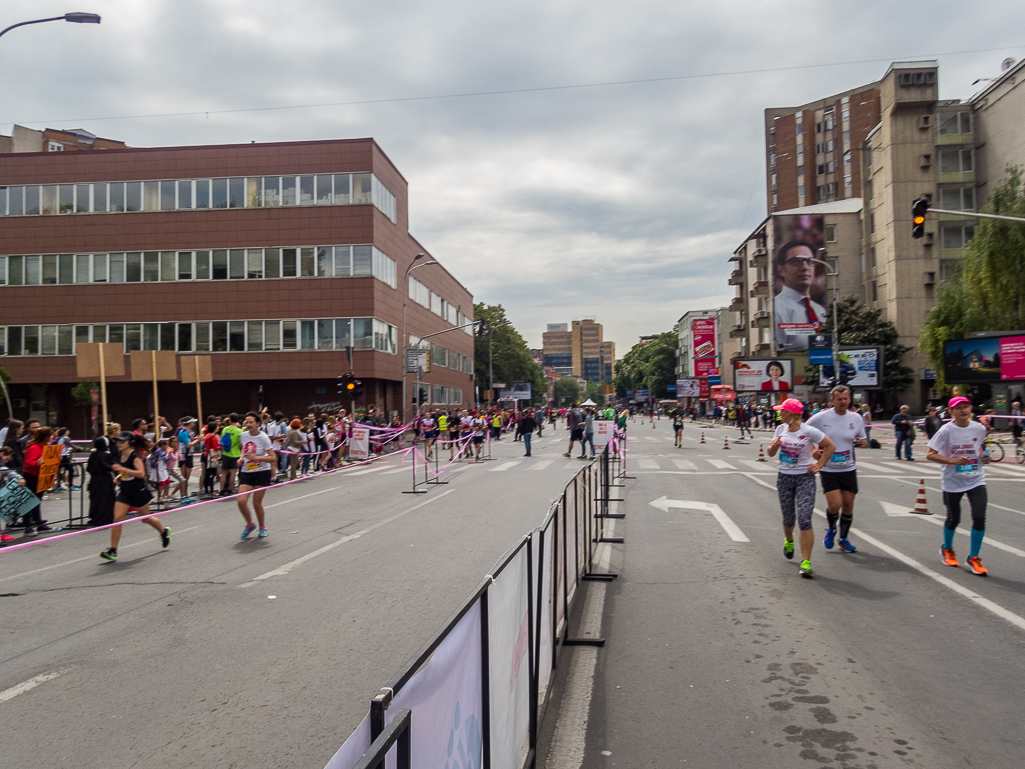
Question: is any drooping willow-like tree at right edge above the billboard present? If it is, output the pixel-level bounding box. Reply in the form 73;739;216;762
918;166;1025;390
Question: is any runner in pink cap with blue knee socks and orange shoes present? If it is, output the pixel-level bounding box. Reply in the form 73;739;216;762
926;397;989;576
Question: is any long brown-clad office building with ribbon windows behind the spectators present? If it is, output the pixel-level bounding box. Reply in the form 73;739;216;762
0;138;474;434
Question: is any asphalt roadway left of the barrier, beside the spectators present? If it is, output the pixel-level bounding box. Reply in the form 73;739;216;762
0;430;583;769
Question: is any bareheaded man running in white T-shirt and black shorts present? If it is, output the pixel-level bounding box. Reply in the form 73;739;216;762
808;385;868;553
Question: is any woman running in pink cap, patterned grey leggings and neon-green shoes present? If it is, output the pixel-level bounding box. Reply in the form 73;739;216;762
769;398;836;579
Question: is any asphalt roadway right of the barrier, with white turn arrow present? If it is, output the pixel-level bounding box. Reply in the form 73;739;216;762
539;420;1025;769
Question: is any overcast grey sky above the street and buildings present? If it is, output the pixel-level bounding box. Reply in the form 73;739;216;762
0;0;1025;356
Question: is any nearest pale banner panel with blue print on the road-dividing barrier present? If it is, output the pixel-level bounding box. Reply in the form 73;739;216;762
384;600;483;768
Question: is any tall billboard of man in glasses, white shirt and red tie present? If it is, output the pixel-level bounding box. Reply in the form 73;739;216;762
769;213;826;352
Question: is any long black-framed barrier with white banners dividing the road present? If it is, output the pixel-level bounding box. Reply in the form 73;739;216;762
326;436;626;769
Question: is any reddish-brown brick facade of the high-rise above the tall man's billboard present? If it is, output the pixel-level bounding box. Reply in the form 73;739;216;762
765;83;879;212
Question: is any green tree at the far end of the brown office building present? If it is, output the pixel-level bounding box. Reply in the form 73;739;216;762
474;302;548;403
